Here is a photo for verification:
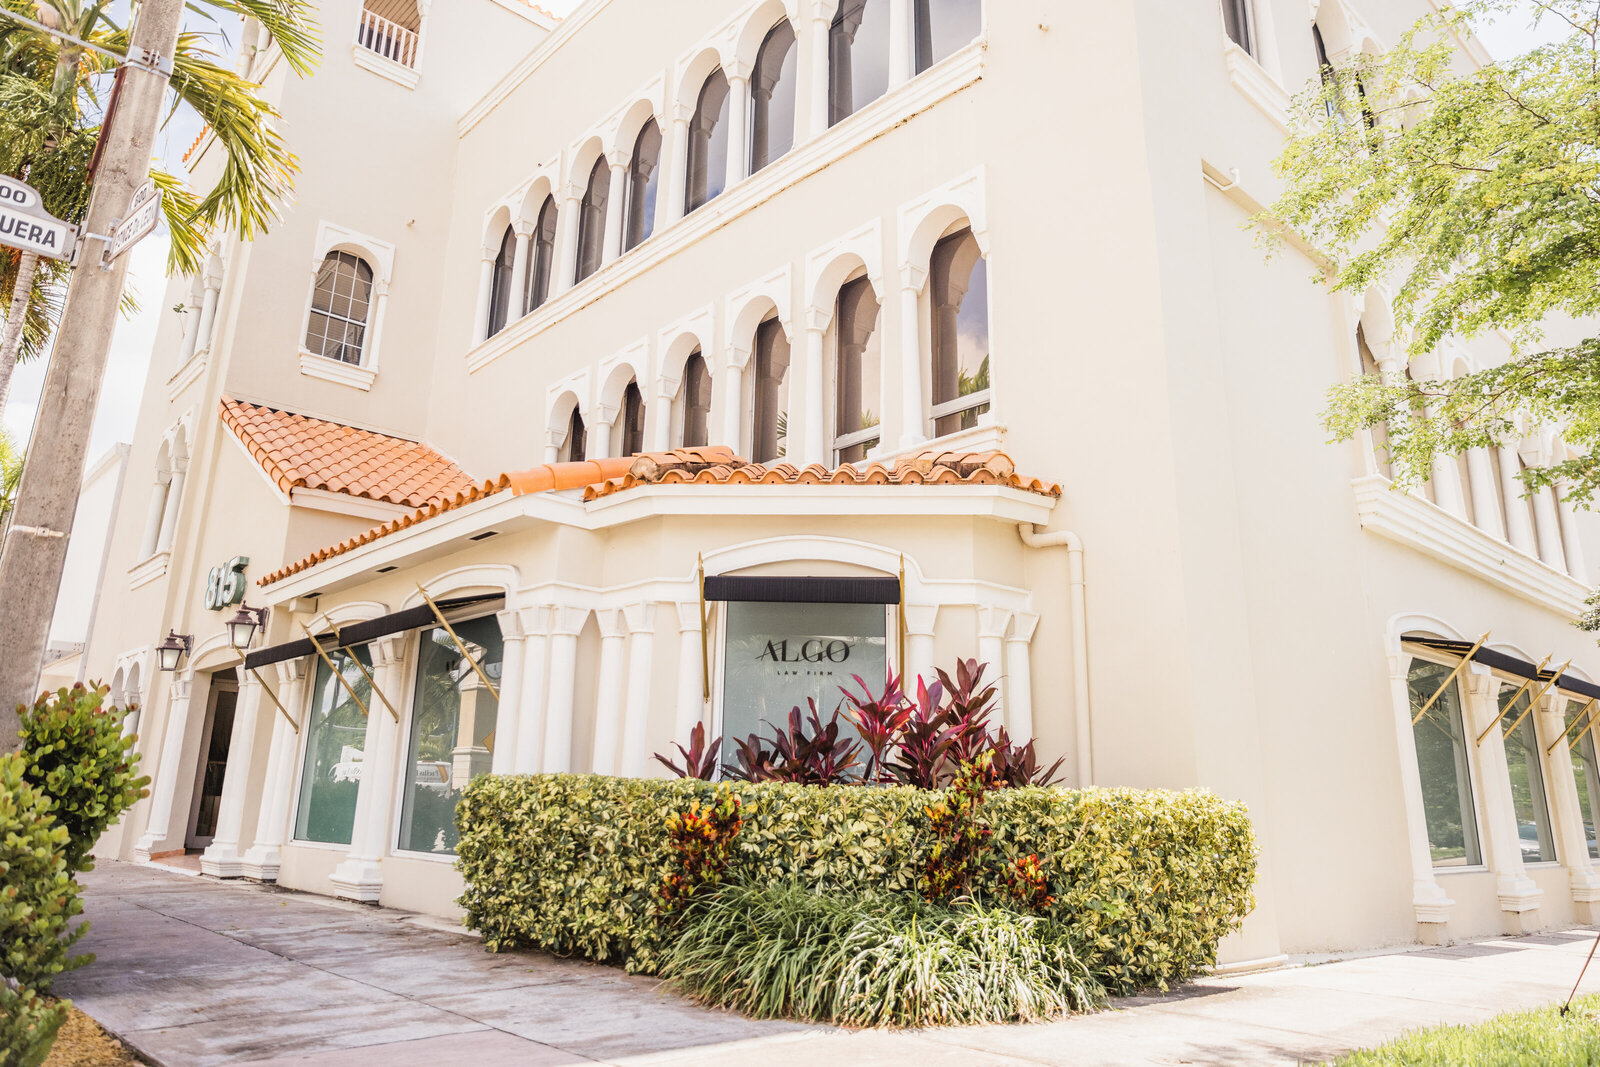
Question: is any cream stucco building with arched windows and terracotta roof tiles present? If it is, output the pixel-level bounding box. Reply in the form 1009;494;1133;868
75;0;1600;963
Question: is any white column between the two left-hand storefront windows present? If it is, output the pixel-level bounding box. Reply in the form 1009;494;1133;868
328;635;406;904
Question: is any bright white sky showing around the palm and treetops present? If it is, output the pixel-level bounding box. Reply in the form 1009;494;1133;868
3;0;1554;464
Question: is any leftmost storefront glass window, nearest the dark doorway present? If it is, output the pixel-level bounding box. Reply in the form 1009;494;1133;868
294;645;373;845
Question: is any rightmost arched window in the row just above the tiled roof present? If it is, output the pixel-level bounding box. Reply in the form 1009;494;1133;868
931;229;989;437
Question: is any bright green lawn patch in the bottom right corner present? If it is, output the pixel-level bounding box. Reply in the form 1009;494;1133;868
1339;993;1600;1067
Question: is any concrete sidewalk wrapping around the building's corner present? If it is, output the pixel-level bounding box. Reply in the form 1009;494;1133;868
56;862;1600;1067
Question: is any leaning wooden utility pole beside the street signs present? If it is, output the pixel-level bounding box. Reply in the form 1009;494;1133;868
0;0;184;752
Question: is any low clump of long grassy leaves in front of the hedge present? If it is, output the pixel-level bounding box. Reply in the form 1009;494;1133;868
664;883;1102;1027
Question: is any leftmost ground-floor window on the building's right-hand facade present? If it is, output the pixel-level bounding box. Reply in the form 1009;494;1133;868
1408;659;1483;867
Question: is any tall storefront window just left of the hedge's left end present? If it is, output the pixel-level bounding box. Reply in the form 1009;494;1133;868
400;616;504;854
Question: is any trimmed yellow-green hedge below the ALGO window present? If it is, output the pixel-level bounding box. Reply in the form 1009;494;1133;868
456;774;1256;992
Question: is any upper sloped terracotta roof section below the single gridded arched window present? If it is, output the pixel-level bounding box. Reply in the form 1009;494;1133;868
218;397;474;507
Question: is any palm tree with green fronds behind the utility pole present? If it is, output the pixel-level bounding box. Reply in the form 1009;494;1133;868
0;0;320;410
